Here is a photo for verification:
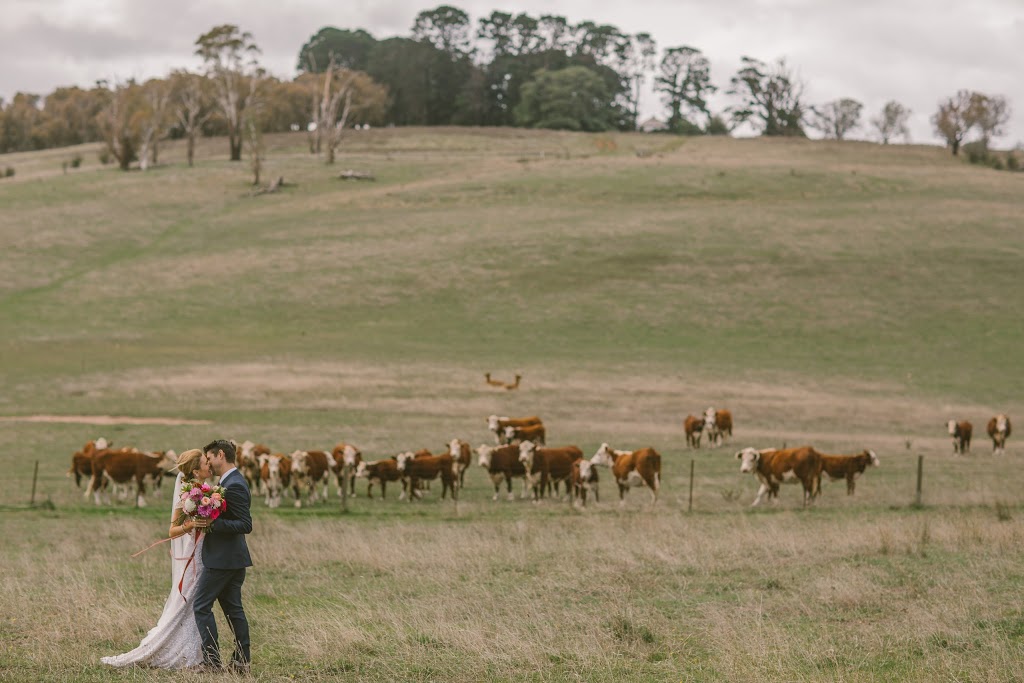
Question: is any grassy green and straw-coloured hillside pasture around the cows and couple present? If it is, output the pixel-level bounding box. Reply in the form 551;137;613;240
0;129;1024;681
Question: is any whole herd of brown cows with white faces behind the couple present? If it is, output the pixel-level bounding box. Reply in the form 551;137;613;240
68;408;1011;508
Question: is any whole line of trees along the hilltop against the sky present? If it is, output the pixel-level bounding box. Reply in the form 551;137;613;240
0;5;1010;169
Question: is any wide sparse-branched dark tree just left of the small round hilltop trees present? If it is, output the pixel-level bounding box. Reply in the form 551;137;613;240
727;56;805;137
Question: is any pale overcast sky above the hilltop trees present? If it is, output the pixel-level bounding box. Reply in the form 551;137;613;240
0;0;1024;146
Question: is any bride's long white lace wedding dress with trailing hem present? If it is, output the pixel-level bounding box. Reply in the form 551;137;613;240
99;473;203;669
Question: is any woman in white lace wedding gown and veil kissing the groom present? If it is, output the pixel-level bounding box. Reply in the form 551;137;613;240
100;449;212;669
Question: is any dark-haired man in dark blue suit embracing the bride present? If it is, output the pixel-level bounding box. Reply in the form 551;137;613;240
193;439;253;673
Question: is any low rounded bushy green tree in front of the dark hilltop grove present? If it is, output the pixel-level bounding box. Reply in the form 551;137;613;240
515;67;617;131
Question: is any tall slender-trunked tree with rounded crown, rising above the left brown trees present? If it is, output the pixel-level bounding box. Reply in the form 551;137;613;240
196;24;263;161
